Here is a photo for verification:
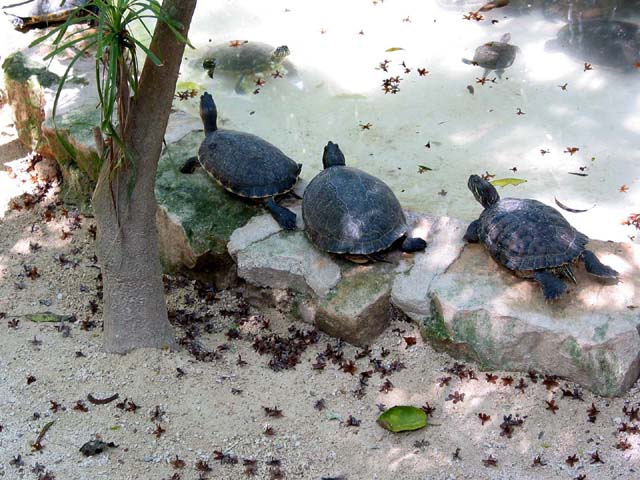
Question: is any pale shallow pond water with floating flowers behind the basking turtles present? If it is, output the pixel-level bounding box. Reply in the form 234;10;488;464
176;0;640;241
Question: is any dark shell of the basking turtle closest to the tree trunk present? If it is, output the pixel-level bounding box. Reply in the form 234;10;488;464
198;129;301;198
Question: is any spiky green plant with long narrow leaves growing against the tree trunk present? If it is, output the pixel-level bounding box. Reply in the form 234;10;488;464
31;0;189;173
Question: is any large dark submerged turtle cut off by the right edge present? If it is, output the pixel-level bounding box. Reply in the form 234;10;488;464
545;19;640;70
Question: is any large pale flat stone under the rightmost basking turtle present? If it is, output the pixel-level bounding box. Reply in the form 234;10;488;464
420;241;640;396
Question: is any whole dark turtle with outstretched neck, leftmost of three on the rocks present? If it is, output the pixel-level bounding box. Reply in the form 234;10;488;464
181;92;302;230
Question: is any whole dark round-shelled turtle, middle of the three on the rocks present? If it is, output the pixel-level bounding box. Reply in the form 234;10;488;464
302;142;427;262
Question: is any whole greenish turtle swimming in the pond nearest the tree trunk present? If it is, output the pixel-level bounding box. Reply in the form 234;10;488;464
202;40;295;94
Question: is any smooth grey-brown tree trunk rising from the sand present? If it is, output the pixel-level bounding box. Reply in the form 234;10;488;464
93;0;196;353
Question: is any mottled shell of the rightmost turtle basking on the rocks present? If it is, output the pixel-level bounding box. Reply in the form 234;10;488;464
478;198;589;272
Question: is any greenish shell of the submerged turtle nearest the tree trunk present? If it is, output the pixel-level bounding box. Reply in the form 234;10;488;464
205;42;284;73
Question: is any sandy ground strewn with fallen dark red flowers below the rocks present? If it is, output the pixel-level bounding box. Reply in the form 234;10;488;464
0;96;640;480
